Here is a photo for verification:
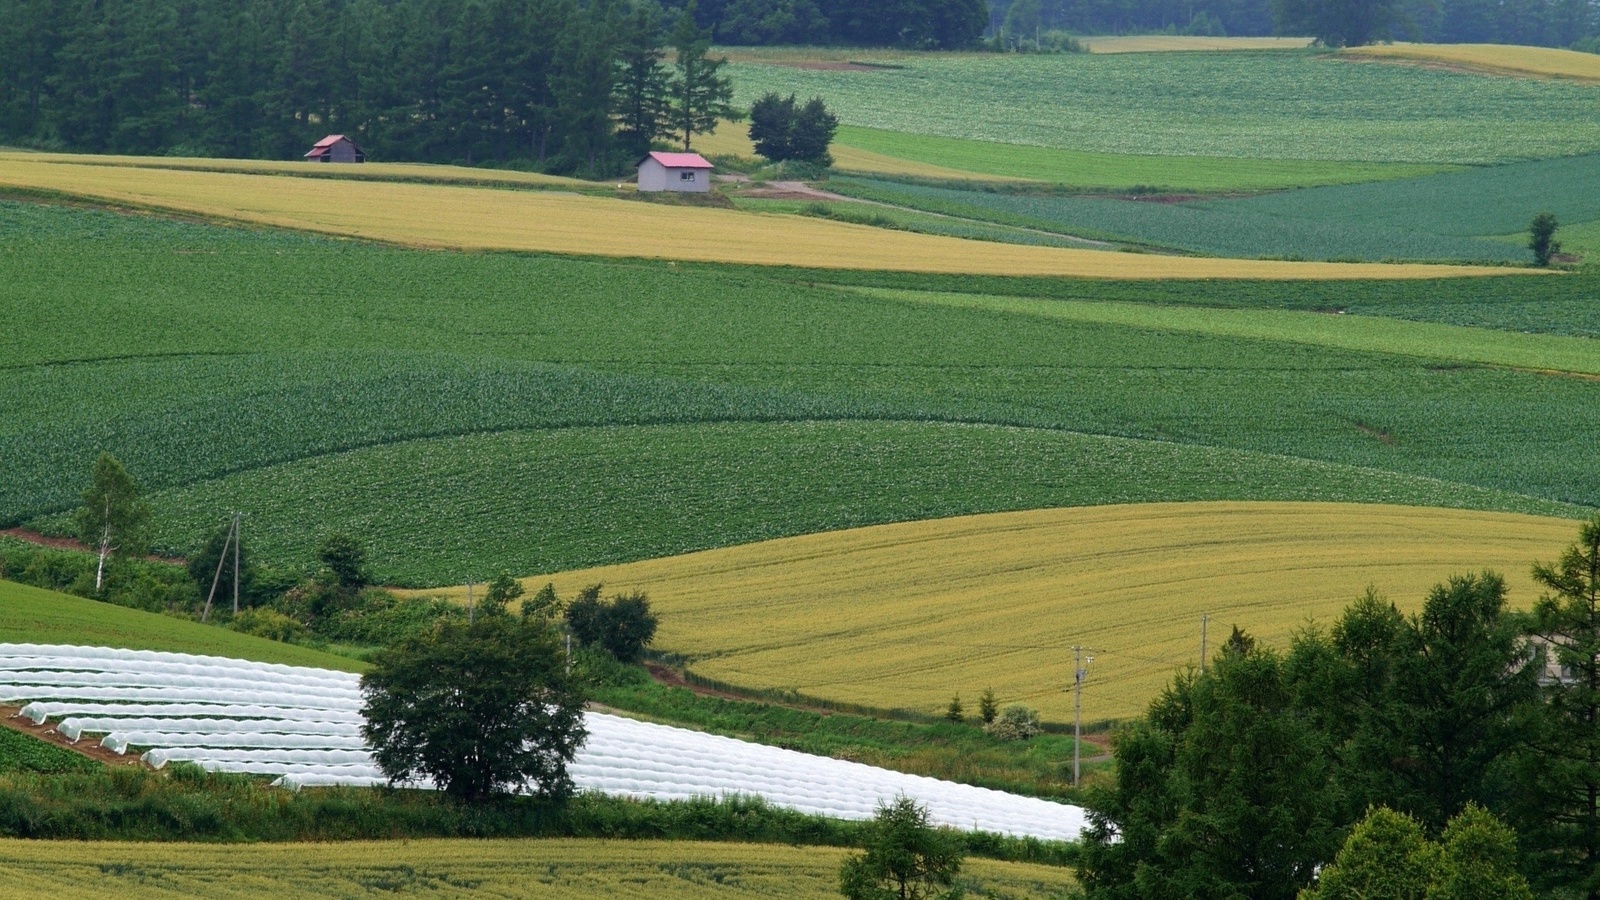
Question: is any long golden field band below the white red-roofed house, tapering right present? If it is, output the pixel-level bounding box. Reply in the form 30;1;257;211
0;157;1523;280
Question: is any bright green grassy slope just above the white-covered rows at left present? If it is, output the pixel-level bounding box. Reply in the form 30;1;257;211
0;580;362;671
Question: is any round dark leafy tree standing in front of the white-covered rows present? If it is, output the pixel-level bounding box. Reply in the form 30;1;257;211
362;607;586;801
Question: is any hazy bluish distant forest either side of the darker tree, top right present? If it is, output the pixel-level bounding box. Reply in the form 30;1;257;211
990;0;1600;46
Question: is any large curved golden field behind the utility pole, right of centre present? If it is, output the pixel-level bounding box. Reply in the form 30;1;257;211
528;503;1578;722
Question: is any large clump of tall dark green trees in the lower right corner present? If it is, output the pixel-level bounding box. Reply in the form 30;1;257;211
1082;517;1600;898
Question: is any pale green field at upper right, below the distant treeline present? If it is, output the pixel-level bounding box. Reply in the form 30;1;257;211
730;51;1600;165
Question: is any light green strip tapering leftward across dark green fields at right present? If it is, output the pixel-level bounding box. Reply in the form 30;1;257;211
858;288;1600;375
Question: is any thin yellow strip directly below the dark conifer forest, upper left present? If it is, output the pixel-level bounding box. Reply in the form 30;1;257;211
0;152;606;191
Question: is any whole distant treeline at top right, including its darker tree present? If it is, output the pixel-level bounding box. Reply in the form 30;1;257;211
989;0;1600;46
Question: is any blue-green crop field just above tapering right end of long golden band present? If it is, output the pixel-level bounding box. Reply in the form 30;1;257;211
829;155;1600;263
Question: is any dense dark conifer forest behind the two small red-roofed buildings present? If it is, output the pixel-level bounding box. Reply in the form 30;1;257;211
0;0;731;175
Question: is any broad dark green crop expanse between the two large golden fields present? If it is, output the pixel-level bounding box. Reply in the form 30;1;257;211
0;203;1600;586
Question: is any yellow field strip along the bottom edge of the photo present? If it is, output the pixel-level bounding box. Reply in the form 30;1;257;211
0;839;1074;900
